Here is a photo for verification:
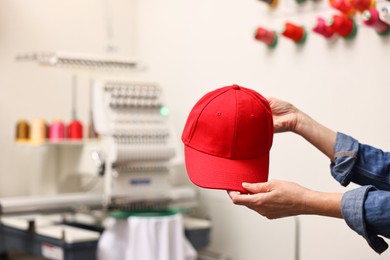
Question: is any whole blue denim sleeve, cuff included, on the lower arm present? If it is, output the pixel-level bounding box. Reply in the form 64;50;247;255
341;186;390;254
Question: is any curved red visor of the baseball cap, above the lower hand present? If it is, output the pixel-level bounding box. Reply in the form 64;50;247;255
184;145;269;192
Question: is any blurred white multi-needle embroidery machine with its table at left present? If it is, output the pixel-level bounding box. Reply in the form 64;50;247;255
0;69;197;259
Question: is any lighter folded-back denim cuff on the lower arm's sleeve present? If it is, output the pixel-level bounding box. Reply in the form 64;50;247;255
341;186;388;254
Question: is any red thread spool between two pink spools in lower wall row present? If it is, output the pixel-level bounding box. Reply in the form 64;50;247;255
326;15;357;40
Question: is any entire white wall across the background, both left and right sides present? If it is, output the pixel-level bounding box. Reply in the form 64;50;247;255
0;0;390;260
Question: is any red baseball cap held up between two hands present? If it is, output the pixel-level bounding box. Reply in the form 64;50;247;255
182;85;274;192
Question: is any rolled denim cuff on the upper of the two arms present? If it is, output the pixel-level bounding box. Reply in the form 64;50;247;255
330;132;359;186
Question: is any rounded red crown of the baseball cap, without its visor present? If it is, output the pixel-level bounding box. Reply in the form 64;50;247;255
182;85;273;160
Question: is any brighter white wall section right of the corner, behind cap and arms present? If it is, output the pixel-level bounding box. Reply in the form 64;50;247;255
133;0;390;260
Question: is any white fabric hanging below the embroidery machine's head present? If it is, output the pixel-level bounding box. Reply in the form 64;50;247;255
97;214;197;260
